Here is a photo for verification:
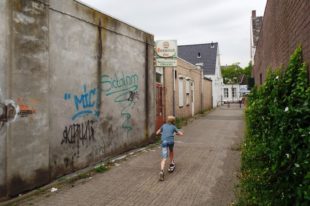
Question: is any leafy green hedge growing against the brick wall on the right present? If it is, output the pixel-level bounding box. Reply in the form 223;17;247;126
238;47;310;206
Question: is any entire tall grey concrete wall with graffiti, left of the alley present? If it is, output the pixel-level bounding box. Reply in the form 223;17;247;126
0;0;155;197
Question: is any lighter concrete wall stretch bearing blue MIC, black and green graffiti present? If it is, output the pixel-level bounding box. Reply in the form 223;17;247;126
50;1;151;176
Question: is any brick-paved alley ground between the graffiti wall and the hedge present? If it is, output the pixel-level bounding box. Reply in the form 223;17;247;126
18;104;244;206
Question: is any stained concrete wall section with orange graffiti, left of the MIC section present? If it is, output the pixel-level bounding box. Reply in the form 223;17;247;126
6;0;49;195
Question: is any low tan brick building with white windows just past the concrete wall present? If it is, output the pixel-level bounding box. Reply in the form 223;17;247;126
156;58;212;127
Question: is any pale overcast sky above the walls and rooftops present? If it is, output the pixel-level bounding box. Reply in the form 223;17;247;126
80;0;267;66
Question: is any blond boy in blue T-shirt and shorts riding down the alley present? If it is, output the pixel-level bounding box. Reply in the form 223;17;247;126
156;116;183;181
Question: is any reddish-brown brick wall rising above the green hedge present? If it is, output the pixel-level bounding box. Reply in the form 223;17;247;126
253;0;310;85
